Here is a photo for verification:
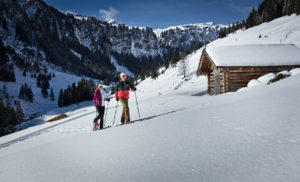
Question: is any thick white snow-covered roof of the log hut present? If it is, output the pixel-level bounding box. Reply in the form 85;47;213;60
206;44;300;66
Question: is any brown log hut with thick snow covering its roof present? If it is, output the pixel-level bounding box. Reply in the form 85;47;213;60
197;44;300;95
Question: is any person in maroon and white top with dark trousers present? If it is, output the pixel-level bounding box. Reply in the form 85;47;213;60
94;82;110;129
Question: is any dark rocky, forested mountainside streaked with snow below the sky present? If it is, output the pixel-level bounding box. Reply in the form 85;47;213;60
0;0;224;77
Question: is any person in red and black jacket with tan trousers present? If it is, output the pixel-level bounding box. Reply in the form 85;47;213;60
115;73;136;124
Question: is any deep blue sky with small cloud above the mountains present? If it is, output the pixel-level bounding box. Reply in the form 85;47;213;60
44;0;262;29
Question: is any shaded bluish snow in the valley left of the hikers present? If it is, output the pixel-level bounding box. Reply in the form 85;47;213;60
0;67;94;128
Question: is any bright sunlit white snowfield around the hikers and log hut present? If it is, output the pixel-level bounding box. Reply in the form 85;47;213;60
0;16;300;182
